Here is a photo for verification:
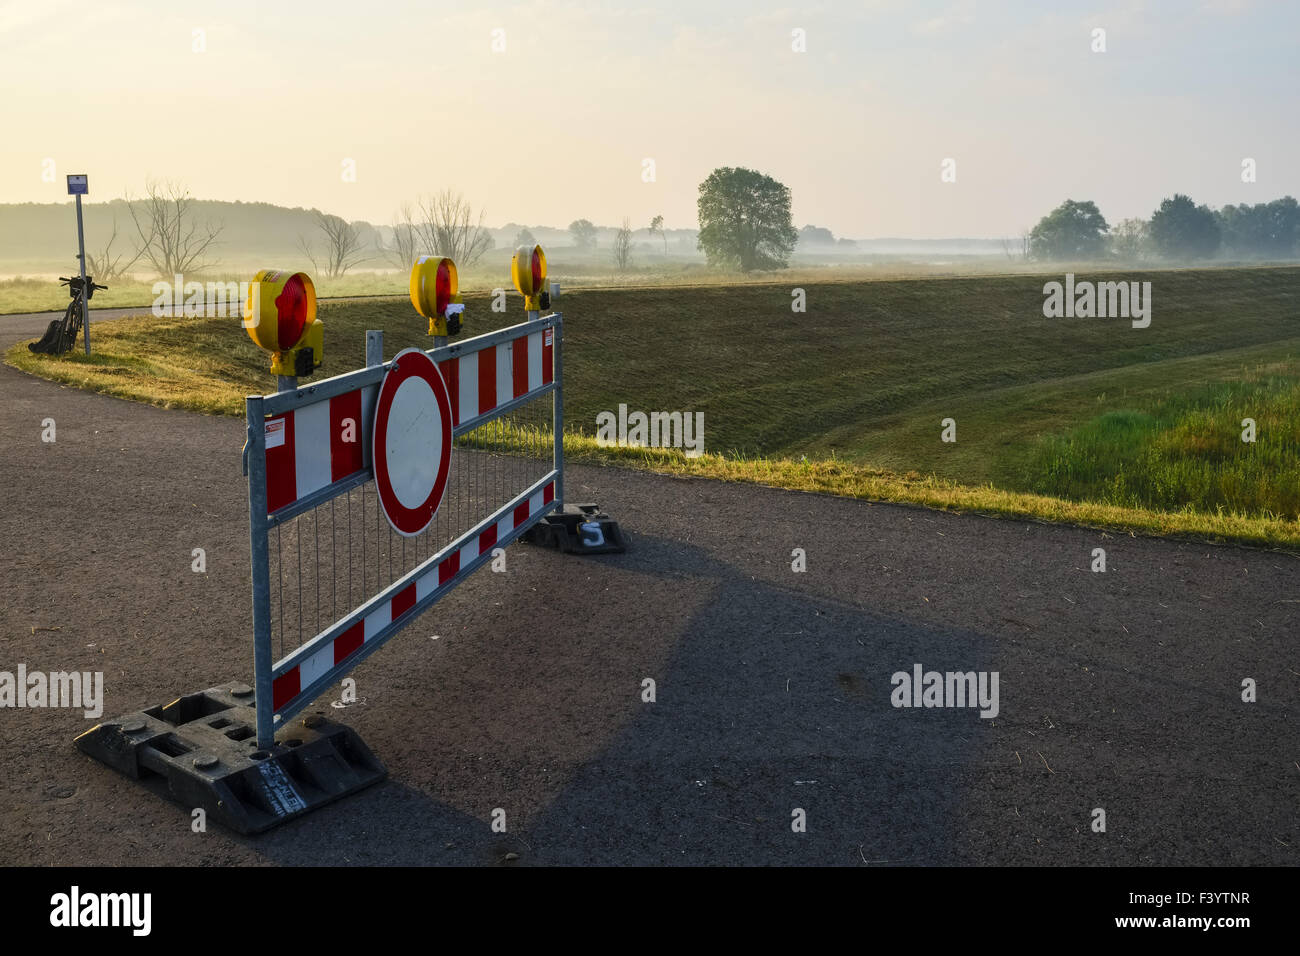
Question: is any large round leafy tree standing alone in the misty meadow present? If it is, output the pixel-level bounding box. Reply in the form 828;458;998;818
697;166;798;272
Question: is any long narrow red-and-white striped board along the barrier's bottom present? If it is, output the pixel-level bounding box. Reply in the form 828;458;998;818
272;481;555;711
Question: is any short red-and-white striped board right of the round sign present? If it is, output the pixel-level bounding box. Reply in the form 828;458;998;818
438;328;555;425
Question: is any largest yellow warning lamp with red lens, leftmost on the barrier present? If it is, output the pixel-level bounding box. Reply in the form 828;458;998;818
243;269;325;378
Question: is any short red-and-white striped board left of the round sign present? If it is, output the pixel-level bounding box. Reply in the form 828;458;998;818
265;385;378;514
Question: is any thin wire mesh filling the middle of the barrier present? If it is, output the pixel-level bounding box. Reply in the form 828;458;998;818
267;394;554;659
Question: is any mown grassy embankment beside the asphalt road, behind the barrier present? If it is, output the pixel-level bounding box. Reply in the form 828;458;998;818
7;268;1300;544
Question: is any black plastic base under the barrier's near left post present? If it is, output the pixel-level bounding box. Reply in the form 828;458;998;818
75;683;389;834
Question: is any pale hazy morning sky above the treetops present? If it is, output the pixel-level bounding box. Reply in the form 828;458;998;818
0;0;1300;238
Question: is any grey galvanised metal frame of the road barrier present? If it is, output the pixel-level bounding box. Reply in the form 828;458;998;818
244;312;564;750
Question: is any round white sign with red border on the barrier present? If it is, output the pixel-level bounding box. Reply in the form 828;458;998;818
373;349;451;537
